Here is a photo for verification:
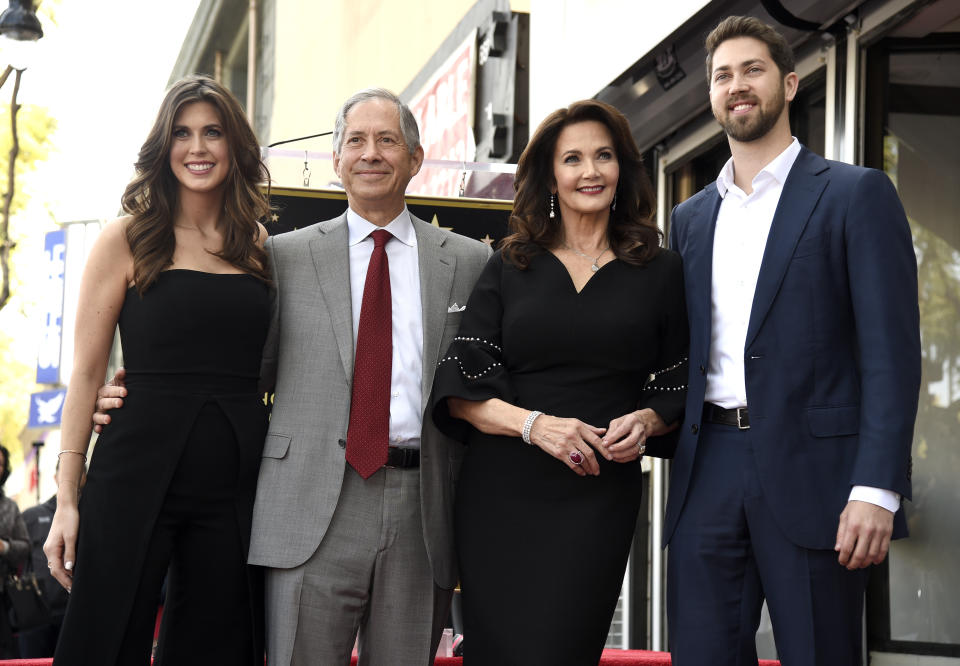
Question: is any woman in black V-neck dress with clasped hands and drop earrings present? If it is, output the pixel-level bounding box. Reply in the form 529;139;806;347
434;101;688;666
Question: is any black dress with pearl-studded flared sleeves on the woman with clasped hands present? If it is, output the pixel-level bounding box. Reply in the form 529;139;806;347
433;251;687;666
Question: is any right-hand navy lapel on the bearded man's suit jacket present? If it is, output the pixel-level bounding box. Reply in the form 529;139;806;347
744;148;830;350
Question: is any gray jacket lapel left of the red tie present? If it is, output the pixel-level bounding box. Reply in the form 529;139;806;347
310;213;353;381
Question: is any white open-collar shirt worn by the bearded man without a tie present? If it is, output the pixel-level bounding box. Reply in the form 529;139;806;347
704;138;900;512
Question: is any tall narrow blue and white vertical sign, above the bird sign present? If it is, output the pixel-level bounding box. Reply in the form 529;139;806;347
36;229;67;382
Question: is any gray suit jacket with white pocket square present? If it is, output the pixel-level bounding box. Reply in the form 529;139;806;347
250;213;490;588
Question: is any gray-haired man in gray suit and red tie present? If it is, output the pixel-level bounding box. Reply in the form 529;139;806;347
98;89;490;666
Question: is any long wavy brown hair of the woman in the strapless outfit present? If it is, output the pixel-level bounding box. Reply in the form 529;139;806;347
121;75;270;295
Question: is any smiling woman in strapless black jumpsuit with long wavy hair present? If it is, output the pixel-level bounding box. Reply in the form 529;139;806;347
44;76;269;666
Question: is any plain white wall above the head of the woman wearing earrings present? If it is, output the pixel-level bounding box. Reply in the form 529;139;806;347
530;0;709;126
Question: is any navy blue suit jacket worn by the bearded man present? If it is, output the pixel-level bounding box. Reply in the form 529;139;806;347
664;148;920;549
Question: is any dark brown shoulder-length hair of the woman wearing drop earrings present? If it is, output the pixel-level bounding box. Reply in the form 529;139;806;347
500;100;663;269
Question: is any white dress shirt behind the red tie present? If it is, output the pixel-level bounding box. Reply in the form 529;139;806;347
347;208;423;448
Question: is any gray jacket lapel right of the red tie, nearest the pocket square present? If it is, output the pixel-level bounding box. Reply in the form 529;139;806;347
410;214;457;406
